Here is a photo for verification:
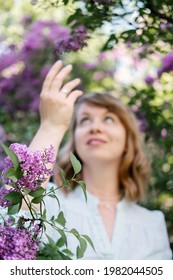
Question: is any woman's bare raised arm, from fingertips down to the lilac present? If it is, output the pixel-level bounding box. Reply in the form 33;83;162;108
30;61;82;188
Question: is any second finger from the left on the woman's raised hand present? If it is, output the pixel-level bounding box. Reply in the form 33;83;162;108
51;64;73;93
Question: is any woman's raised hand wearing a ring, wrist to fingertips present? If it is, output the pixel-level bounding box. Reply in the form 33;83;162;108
40;61;82;130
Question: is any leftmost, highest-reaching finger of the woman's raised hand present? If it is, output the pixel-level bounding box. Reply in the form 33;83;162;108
42;60;62;92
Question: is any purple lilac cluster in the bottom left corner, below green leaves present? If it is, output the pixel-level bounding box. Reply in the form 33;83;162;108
0;224;39;260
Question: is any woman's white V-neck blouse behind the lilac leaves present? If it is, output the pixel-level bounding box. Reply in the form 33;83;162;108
43;183;172;260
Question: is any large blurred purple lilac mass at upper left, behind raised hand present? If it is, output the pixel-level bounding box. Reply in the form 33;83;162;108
0;19;88;114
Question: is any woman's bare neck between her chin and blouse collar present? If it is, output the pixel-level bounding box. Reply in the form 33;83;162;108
83;164;120;200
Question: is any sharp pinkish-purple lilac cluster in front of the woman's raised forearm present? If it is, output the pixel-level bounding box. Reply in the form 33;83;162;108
2;143;55;191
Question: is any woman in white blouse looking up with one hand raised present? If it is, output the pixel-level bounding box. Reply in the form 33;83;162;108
30;61;171;259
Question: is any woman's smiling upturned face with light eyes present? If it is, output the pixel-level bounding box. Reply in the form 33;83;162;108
74;103;126;164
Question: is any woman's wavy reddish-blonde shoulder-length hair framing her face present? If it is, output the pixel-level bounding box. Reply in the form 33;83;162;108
54;93;150;201
